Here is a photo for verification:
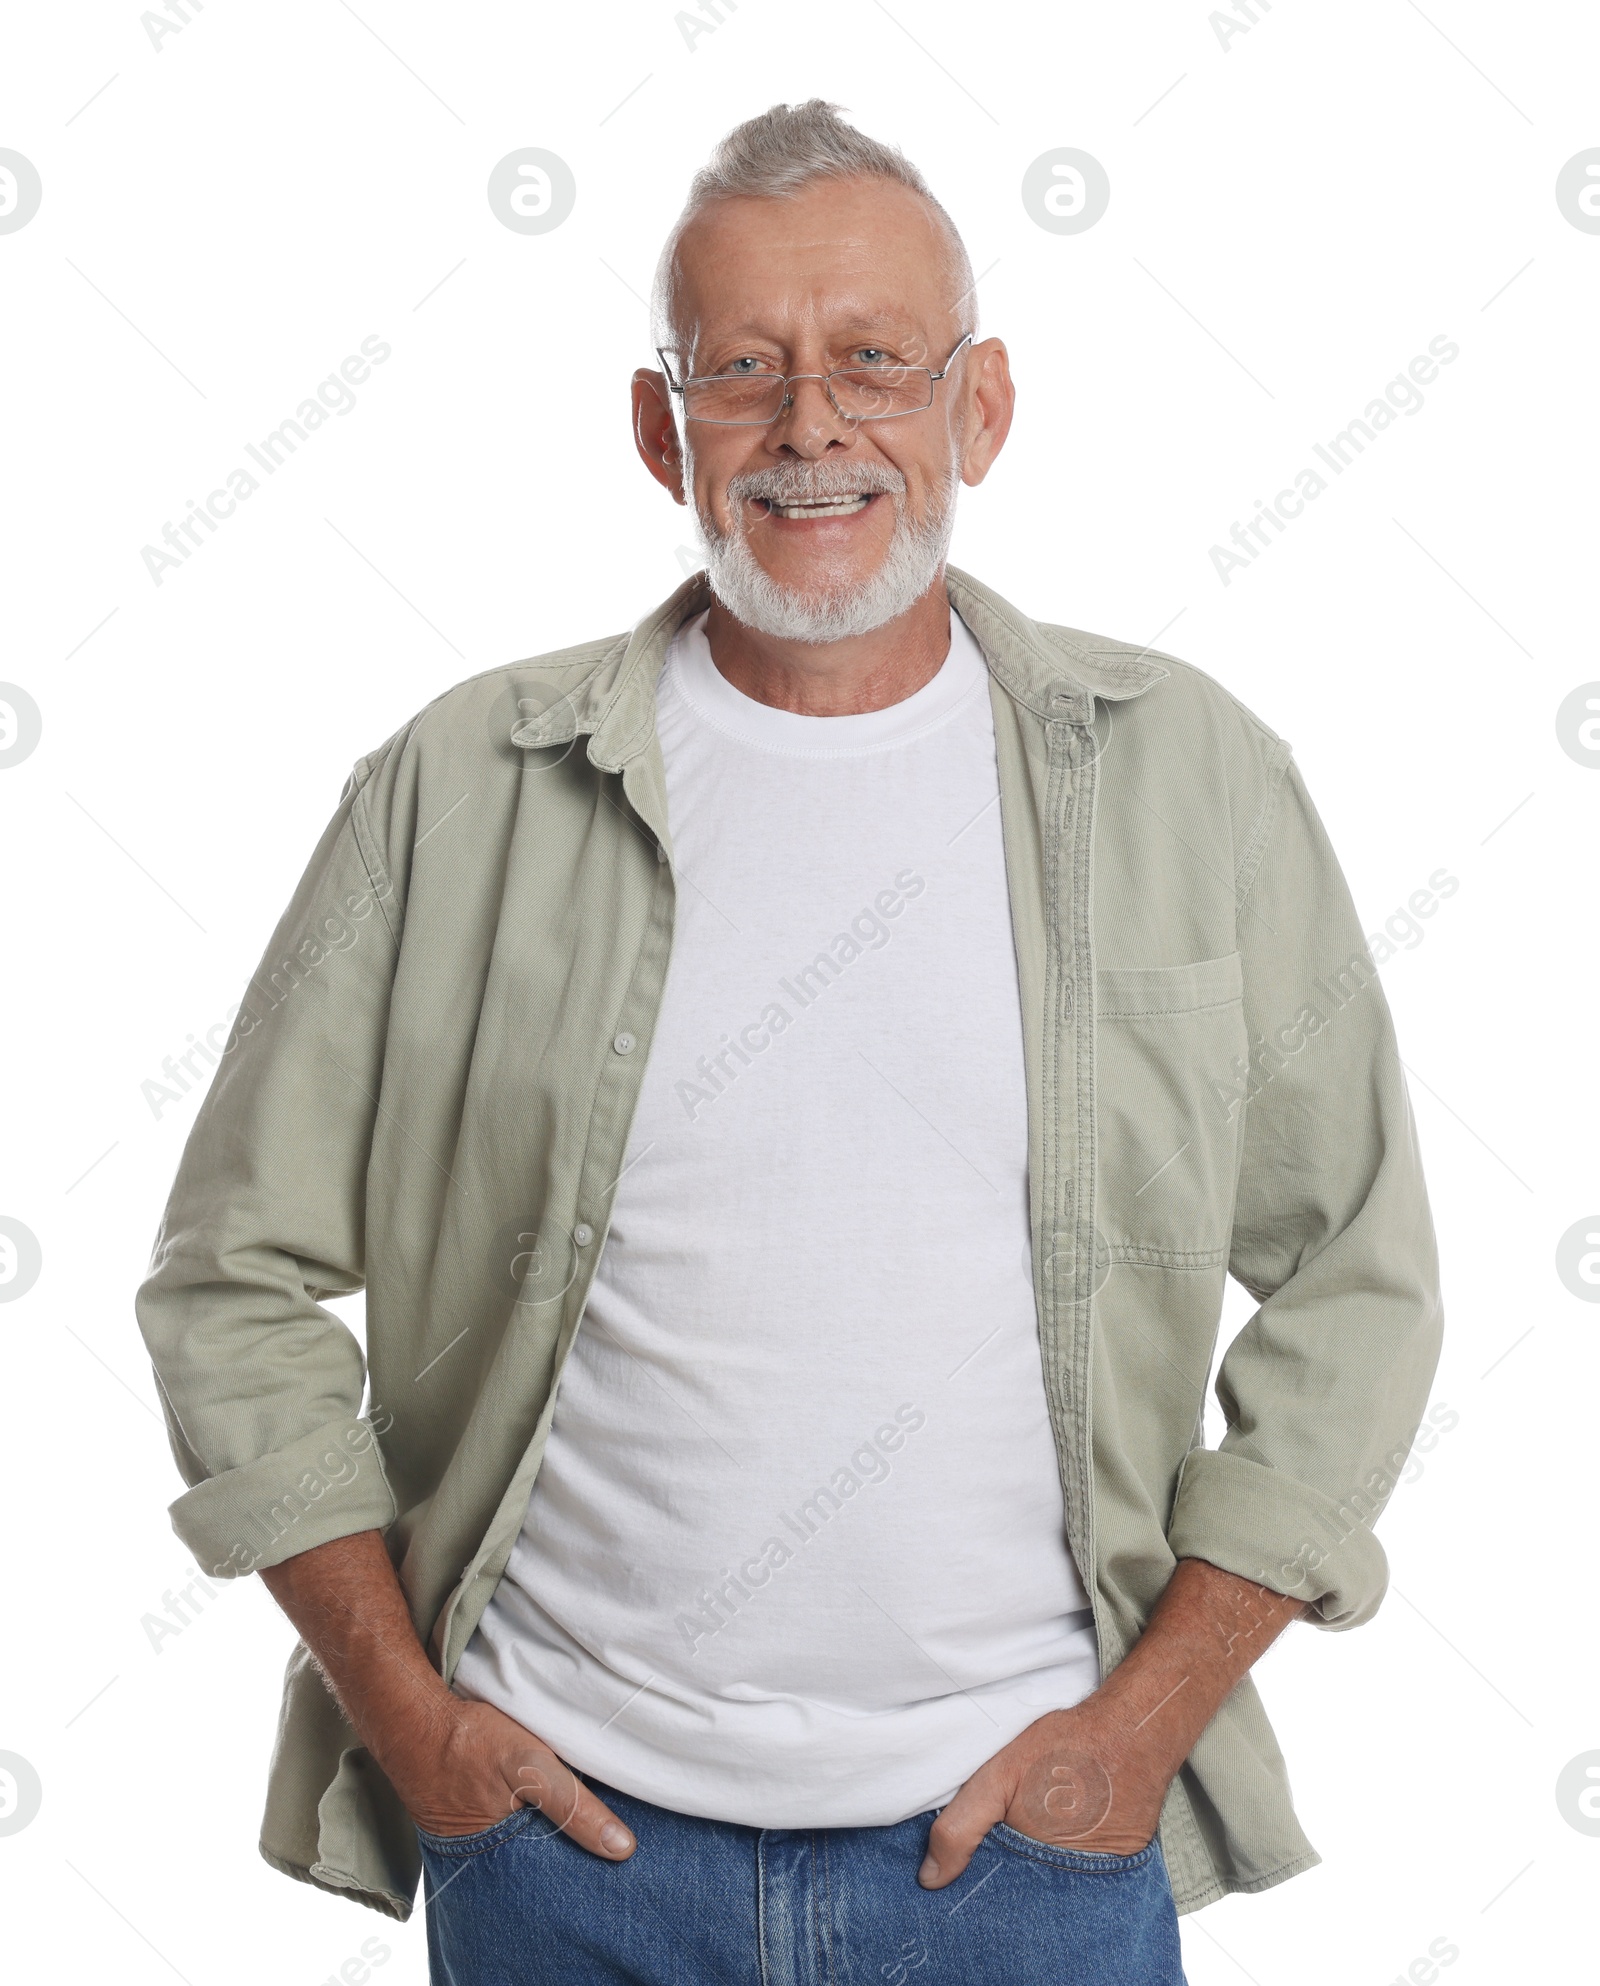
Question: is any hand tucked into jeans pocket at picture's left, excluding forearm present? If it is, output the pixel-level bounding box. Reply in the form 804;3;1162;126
389;1696;635;1861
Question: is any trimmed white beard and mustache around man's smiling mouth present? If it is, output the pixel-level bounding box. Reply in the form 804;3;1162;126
685;447;959;643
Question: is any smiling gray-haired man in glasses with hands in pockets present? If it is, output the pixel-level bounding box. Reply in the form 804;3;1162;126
139;101;1439;1986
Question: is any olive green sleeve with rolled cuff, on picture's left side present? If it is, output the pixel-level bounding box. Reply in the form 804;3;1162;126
135;761;399;1579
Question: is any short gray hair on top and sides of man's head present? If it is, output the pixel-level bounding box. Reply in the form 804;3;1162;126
651;97;979;350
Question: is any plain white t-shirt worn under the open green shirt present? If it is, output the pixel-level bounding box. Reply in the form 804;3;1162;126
457;614;1100;1827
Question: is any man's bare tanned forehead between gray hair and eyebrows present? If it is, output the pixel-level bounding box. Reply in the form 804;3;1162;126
677;179;957;340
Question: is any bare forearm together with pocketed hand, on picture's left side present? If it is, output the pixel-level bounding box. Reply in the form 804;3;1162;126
262;1531;637;1861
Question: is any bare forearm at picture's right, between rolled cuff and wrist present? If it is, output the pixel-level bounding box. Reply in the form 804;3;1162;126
1088;1559;1306;1772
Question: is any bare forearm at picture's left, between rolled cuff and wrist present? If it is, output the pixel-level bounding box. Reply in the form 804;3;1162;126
260;1531;455;1764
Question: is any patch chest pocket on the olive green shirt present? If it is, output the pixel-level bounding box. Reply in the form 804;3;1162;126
1094;951;1249;1267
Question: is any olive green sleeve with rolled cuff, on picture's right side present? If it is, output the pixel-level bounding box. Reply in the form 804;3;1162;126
1167;763;1441;1629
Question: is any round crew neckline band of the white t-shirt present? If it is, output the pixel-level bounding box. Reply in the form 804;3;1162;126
669;610;989;759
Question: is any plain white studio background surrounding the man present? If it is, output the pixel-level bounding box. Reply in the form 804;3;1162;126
0;0;1600;1986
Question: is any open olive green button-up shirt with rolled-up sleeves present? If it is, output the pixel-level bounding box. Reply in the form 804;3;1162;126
137;570;1439;1918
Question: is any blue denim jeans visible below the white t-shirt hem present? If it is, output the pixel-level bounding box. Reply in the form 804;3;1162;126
419;1779;1183;1986
